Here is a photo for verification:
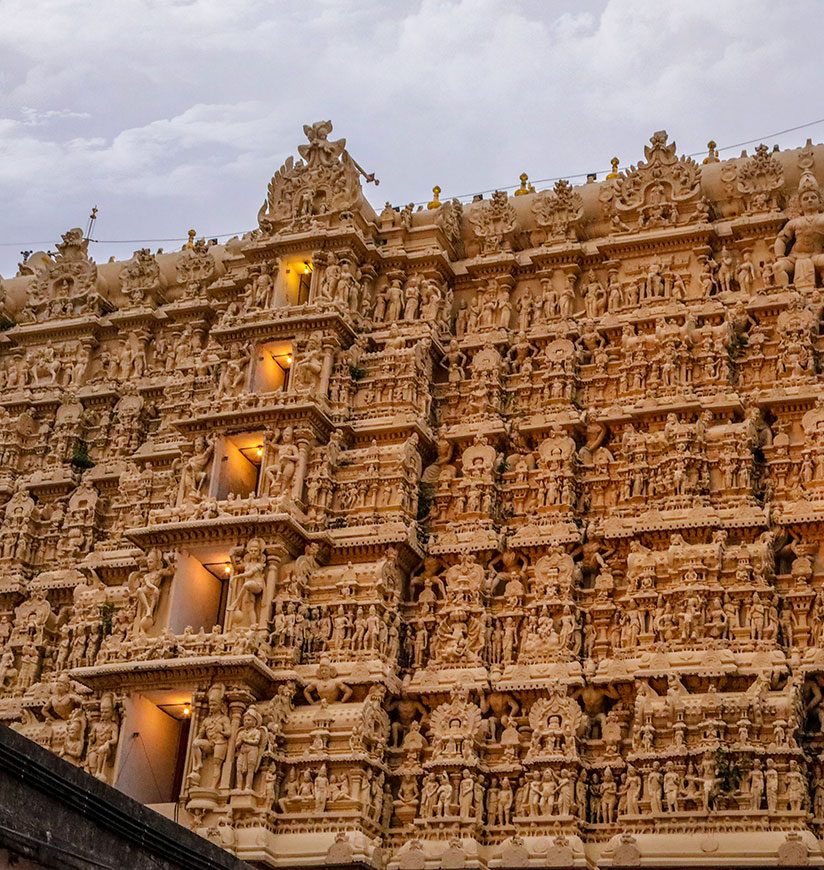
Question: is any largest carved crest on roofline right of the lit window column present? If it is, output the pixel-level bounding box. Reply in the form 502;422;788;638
600;130;701;232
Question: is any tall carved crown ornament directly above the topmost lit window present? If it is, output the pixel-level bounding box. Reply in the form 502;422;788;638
258;121;361;233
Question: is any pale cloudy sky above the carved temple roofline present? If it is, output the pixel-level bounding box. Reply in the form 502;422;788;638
0;0;824;275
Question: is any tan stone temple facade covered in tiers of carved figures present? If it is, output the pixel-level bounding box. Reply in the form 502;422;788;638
0;122;824;870
